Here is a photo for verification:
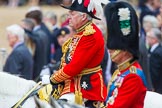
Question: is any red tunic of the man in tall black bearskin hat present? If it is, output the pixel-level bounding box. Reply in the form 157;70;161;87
107;61;146;108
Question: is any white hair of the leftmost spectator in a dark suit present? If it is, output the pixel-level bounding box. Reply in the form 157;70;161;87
6;24;25;42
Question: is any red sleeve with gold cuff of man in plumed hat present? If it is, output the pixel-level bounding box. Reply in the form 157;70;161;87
51;24;104;83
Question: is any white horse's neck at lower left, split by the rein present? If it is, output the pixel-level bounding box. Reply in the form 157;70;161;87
0;72;36;108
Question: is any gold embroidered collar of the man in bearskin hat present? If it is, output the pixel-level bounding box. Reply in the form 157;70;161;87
118;58;134;71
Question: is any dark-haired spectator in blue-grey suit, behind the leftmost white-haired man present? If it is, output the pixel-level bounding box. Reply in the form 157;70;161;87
26;10;50;79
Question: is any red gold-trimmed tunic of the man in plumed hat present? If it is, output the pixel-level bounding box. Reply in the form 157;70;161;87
50;23;107;101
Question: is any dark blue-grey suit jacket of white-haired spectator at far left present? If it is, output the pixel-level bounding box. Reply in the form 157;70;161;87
3;43;33;80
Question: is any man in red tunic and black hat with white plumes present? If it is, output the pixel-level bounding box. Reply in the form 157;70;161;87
50;0;107;108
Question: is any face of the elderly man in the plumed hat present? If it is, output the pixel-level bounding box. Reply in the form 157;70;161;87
69;11;82;30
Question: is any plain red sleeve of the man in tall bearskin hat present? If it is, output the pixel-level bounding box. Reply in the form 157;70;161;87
107;74;146;108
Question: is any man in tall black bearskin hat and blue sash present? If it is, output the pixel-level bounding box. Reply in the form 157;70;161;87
104;2;146;108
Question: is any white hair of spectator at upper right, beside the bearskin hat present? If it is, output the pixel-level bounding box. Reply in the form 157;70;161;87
143;15;159;28
